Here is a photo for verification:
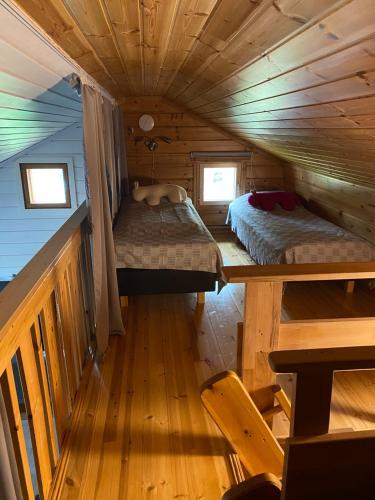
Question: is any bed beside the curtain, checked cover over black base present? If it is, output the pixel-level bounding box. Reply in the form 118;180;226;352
114;198;222;295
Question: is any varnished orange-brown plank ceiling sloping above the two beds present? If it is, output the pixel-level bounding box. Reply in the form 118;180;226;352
11;0;375;185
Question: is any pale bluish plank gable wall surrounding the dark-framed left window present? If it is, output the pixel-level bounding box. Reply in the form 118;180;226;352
0;124;86;281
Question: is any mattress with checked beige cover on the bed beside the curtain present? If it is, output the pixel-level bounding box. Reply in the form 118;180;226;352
114;198;222;274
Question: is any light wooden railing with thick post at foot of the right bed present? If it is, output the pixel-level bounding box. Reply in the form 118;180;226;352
223;262;375;410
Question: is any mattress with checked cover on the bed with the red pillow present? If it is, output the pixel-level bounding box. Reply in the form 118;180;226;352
227;194;375;264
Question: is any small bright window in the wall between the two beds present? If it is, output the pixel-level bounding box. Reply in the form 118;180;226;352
200;162;239;205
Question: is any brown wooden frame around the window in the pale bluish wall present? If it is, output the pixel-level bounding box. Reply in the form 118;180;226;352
19;162;72;209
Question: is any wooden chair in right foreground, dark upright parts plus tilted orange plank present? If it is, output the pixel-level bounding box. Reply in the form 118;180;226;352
201;346;375;500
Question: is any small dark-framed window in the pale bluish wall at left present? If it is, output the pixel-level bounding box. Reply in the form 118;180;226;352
20;163;71;208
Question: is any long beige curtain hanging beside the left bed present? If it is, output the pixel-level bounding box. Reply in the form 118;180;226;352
82;84;124;356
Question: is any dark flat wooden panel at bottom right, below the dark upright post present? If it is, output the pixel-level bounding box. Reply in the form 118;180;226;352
282;430;375;500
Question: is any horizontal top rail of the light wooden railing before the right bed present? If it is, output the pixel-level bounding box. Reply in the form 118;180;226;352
223;261;375;283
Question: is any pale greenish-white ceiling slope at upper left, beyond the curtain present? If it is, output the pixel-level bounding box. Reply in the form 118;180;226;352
0;2;81;164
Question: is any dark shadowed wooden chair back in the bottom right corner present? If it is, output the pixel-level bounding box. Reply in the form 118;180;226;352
270;346;375;500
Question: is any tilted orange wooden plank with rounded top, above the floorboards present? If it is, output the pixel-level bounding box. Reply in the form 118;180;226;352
201;371;284;477
